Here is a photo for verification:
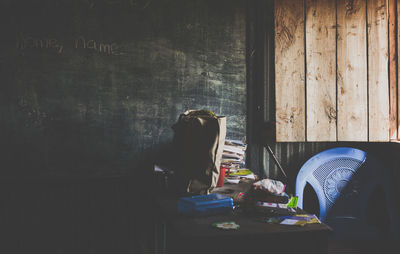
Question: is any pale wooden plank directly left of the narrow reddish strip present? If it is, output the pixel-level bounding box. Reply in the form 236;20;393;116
367;0;389;141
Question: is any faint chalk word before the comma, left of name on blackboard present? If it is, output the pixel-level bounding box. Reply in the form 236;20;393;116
16;35;64;54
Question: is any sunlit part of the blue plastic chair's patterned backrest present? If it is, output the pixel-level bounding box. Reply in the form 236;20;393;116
296;147;366;221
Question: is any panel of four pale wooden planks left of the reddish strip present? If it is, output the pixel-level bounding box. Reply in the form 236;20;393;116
275;0;390;142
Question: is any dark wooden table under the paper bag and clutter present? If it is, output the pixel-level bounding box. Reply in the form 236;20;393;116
157;181;332;254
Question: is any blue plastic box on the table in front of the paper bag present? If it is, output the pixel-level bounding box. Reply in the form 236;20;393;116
178;193;233;215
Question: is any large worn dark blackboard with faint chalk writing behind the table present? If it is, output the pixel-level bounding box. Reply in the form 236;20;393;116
0;0;246;176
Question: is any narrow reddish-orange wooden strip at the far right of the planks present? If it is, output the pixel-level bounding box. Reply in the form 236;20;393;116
388;0;399;140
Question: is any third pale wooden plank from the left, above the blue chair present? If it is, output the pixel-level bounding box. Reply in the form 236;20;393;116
337;0;368;141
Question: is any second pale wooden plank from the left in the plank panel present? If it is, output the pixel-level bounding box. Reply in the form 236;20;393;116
306;0;336;141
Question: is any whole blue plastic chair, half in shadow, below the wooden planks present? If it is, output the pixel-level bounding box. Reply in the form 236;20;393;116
296;147;400;243
